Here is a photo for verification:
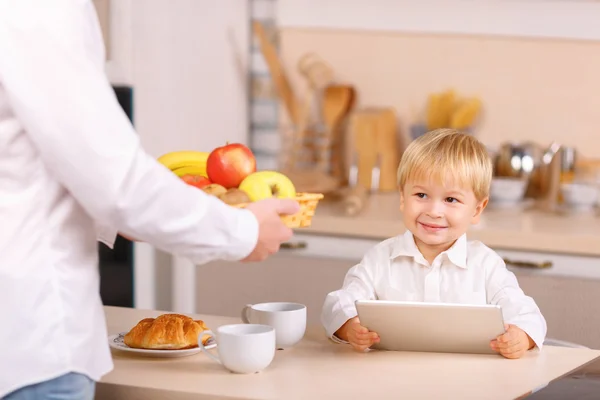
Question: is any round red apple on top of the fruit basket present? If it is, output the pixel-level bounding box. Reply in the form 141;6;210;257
206;143;256;189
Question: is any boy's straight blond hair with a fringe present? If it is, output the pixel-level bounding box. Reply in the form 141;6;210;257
398;129;492;201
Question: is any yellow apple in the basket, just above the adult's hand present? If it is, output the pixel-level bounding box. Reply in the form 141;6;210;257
239;171;296;201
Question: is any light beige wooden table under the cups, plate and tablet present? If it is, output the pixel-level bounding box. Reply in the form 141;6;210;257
96;307;600;400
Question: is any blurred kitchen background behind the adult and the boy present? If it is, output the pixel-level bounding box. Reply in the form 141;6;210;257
94;0;600;394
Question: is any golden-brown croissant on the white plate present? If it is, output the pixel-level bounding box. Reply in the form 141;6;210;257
124;314;210;350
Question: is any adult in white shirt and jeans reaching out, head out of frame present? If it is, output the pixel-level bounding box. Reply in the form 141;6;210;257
0;0;298;400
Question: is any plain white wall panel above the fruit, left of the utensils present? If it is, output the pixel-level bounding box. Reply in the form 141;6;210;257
106;0;249;156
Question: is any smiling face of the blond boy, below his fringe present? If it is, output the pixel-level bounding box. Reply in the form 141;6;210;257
400;180;487;263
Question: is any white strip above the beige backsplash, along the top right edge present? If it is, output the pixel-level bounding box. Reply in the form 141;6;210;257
277;0;600;40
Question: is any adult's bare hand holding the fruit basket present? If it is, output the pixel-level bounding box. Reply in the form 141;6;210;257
242;199;300;261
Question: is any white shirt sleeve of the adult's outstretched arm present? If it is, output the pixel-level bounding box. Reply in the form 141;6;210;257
0;0;258;263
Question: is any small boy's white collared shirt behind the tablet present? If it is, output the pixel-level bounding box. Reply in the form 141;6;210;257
321;231;546;348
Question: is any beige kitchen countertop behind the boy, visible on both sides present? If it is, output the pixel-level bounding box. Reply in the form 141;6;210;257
298;193;600;256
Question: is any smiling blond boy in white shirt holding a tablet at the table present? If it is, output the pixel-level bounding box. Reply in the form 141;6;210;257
321;129;546;358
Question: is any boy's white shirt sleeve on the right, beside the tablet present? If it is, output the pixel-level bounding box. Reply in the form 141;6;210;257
486;257;547;349
